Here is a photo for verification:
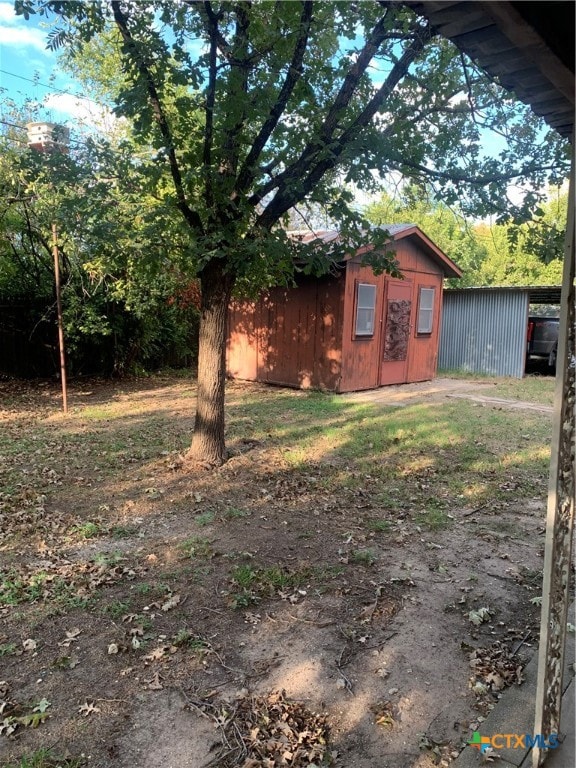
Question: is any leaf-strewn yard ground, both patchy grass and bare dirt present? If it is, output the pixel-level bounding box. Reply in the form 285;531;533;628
0;377;548;768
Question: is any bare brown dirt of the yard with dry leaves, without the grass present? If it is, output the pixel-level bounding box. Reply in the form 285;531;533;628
0;379;550;768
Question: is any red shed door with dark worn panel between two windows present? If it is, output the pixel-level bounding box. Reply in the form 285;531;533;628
380;278;412;385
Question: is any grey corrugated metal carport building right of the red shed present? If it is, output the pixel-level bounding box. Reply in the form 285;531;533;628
438;286;560;379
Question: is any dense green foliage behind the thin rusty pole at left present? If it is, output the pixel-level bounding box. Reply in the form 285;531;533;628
0;103;197;374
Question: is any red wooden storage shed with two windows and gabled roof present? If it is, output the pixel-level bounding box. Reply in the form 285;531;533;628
227;224;462;392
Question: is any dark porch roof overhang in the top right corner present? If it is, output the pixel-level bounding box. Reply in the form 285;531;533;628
406;0;576;138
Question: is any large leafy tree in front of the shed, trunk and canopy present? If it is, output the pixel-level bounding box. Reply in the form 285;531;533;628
16;0;567;464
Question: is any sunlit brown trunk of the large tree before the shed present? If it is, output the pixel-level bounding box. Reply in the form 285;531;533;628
187;261;234;466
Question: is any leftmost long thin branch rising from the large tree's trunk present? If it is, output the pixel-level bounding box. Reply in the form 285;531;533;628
111;0;204;232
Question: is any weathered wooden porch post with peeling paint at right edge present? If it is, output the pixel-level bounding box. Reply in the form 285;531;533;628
532;147;576;768
